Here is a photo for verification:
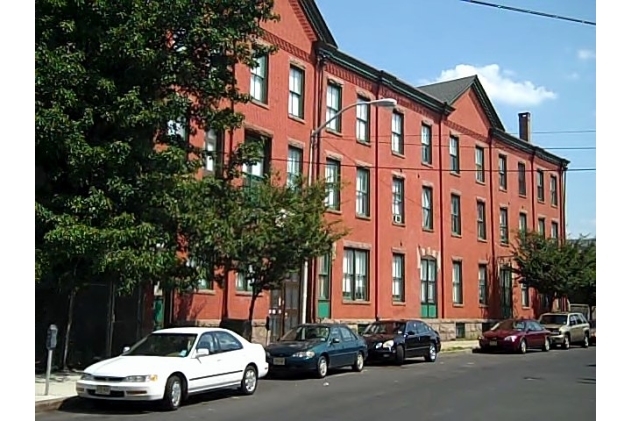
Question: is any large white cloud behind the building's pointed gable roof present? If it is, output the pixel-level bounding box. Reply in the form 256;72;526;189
424;64;557;107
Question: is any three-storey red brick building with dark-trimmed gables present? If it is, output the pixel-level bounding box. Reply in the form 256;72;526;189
165;0;568;337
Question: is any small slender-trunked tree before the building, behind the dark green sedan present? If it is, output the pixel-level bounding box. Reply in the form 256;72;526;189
183;142;346;321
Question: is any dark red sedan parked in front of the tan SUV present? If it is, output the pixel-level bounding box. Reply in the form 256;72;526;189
479;319;550;354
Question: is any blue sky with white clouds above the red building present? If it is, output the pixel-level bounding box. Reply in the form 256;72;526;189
317;0;596;236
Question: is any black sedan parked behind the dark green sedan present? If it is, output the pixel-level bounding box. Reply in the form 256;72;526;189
363;320;441;364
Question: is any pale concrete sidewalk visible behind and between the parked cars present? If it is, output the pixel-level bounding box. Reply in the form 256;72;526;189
35;341;478;413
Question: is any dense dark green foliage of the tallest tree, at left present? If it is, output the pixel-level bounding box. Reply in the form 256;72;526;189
35;0;276;290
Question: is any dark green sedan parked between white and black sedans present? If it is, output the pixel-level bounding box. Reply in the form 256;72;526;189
265;323;368;378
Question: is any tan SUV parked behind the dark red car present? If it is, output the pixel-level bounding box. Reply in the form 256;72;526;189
539;312;589;349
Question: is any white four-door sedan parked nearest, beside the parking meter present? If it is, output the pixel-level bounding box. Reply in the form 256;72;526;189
77;327;269;410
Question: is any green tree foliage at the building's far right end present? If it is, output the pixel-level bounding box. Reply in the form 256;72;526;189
512;232;596;303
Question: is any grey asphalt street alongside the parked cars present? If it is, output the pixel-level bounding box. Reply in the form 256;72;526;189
36;348;596;421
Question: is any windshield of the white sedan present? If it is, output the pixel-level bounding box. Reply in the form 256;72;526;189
125;333;197;357
